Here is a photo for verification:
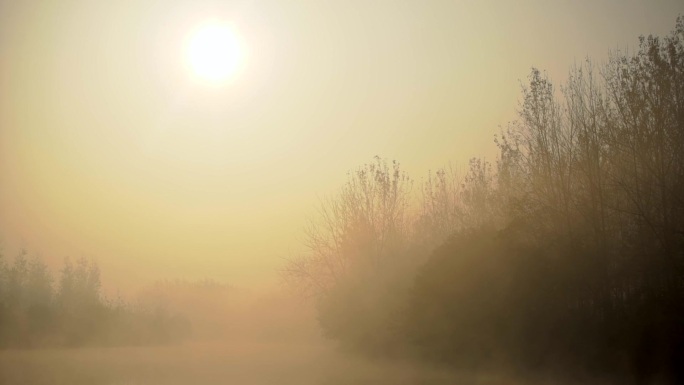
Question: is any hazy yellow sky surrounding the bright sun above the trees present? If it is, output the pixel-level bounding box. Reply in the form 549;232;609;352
0;0;684;286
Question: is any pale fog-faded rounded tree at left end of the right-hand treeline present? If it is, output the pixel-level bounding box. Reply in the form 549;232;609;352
282;157;414;350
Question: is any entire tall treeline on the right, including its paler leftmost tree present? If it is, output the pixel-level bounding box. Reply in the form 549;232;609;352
283;17;684;383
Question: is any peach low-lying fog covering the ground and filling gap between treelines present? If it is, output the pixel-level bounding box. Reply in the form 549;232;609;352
0;284;462;385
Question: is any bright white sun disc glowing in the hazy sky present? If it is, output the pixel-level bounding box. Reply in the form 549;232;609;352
185;22;245;84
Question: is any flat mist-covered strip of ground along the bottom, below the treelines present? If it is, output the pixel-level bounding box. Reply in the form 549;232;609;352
0;343;472;385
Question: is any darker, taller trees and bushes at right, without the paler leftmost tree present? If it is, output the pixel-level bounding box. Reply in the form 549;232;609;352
404;17;684;382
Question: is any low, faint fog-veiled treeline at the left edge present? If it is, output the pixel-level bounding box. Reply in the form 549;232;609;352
0;252;190;348
